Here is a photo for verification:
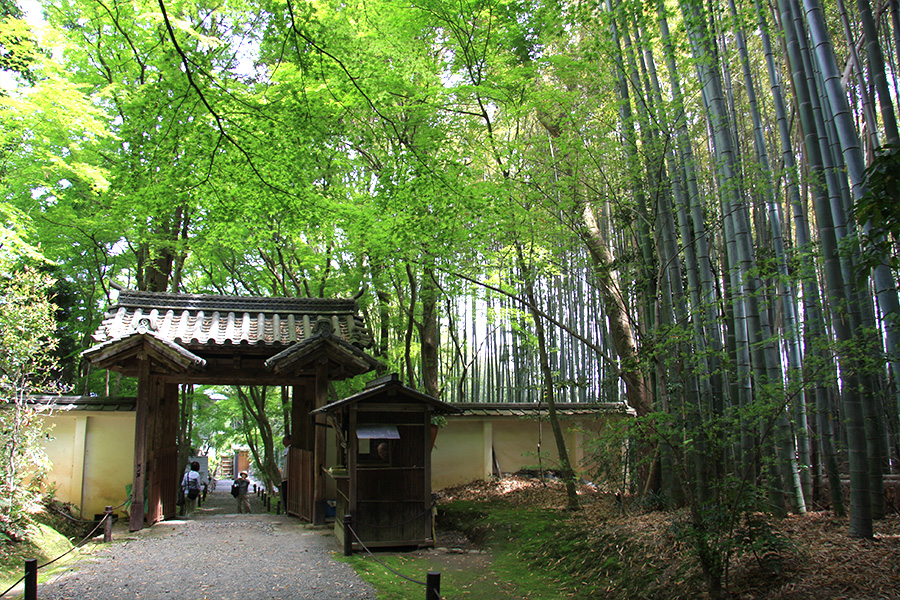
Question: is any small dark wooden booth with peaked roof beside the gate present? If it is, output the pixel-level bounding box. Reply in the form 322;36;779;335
313;374;460;550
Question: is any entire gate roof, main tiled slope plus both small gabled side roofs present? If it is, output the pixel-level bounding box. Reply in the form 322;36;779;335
84;290;379;379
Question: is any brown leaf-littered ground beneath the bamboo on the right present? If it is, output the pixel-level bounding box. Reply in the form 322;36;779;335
420;477;900;600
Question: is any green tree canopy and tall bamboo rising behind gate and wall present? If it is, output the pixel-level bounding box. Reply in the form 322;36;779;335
0;0;900;552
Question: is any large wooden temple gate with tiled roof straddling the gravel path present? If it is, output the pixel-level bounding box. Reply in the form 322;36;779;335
84;290;380;531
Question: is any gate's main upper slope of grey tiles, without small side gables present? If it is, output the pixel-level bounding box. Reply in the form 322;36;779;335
93;290;373;349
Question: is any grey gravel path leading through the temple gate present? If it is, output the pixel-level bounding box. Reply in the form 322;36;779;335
38;482;375;600
